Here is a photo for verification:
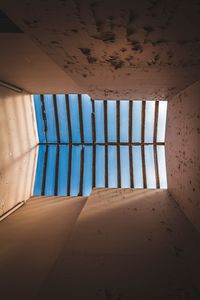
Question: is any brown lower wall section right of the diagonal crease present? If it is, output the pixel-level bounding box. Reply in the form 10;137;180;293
38;189;200;300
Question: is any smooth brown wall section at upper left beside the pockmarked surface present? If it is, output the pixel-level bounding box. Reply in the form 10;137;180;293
0;33;81;94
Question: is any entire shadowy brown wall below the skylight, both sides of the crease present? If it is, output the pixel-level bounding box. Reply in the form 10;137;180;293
0;189;200;300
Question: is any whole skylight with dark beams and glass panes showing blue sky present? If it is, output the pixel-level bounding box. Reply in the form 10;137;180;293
34;94;167;196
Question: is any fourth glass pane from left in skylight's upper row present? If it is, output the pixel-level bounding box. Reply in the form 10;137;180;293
69;94;81;143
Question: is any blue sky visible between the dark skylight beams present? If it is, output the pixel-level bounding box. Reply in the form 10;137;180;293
34;94;167;196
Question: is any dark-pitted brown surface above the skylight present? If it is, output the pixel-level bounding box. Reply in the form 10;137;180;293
0;0;200;99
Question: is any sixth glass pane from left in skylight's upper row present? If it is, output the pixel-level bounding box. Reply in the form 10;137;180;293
95;100;105;143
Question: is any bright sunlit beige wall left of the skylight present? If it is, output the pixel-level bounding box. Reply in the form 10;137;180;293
0;87;37;215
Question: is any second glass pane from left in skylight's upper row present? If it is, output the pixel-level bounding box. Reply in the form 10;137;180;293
44;95;57;143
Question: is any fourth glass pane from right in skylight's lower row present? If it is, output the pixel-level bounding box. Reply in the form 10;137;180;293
120;146;130;188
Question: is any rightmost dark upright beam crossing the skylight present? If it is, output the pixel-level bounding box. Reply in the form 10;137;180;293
153;101;160;189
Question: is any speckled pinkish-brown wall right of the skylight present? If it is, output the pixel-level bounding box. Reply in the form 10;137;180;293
166;81;200;231
